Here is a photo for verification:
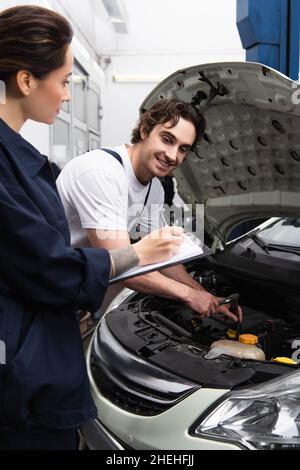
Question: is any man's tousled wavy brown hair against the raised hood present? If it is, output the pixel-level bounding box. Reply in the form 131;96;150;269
131;99;206;149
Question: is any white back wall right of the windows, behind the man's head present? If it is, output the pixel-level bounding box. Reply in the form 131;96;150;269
102;0;245;145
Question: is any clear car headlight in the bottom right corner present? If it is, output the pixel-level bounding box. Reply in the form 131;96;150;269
193;372;300;450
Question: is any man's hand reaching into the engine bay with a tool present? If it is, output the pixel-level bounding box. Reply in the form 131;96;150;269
185;288;242;321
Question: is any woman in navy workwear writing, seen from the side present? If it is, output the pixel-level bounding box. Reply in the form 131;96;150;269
0;6;181;449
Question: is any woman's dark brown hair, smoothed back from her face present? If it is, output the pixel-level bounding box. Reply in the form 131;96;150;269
0;5;73;83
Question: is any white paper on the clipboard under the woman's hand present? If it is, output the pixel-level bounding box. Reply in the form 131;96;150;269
109;233;210;284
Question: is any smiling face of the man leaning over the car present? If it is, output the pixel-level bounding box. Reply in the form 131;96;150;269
138;118;196;181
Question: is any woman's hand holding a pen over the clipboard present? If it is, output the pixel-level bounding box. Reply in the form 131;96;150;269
132;226;184;266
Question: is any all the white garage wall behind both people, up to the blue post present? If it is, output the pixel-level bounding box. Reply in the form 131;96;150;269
0;0;244;155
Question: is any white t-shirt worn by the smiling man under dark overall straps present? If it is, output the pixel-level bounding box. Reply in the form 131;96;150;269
57;145;165;247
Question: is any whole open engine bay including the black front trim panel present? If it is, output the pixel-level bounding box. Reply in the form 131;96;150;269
100;259;300;389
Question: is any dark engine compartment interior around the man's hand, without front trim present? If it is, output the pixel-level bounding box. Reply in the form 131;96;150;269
135;258;300;362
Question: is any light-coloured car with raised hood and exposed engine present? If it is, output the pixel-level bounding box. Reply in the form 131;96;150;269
82;63;300;450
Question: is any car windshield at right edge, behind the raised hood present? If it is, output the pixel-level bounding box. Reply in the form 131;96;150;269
256;218;300;248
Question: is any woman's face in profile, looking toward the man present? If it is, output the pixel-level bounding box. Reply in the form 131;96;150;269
23;46;74;124
